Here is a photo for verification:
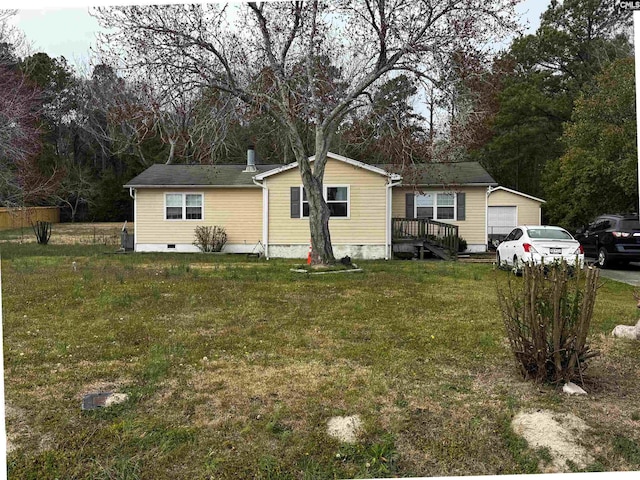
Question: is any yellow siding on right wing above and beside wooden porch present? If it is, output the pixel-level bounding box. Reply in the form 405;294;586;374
392;187;487;245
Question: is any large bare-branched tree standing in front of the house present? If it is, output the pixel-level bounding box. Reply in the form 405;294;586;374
94;0;517;263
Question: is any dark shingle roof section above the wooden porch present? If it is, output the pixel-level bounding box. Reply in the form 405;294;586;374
376;162;498;186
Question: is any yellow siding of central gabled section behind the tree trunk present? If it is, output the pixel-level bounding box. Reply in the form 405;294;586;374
266;159;387;245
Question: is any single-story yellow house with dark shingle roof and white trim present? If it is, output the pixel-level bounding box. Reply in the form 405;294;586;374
125;150;544;259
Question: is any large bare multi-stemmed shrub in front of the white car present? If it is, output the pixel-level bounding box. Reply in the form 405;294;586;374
498;262;598;383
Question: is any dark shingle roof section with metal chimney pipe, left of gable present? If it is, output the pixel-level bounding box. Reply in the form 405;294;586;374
125;163;282;187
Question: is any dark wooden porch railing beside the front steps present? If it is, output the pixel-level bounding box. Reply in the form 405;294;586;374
391;218;458;257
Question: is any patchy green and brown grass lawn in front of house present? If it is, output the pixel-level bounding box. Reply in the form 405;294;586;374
0;228;640;479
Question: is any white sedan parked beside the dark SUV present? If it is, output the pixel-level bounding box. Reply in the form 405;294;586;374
496;225;584;272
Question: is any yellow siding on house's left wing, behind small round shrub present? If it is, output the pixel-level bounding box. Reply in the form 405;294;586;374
136;188;262;245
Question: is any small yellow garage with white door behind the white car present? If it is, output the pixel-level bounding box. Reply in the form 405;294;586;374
487;187;545;244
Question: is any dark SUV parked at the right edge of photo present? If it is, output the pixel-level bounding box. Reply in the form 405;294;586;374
575;214;640;268
